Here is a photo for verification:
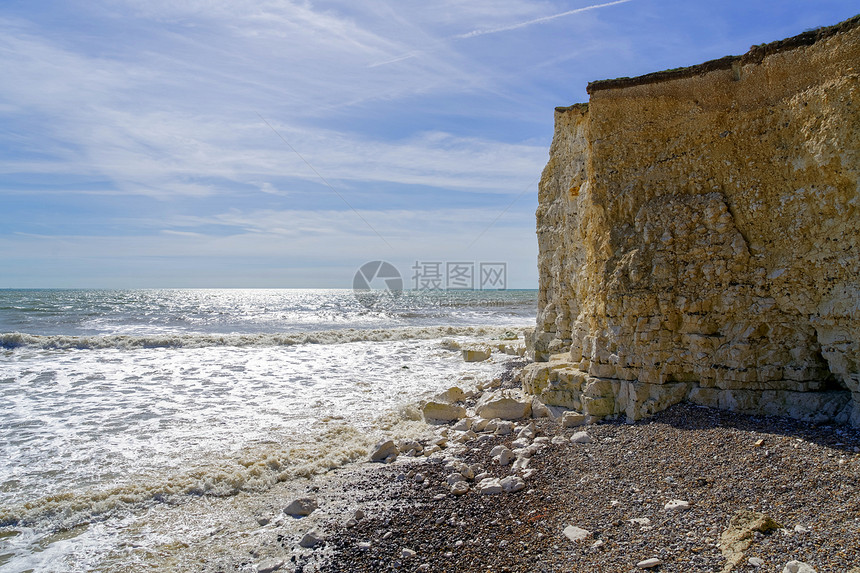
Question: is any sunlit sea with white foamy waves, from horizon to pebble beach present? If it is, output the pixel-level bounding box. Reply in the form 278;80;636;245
0;289;536;573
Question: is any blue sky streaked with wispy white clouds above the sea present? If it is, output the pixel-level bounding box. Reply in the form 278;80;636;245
0;0;860;288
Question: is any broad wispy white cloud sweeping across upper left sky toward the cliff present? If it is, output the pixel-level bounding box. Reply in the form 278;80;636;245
0;7;546;198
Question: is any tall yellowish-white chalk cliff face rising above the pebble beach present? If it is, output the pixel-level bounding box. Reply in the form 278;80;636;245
524;18;860;425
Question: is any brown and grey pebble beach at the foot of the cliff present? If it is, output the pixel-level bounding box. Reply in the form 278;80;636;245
260;360;860;573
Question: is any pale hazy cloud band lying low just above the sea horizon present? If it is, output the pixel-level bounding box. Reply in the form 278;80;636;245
0;206;537;288
